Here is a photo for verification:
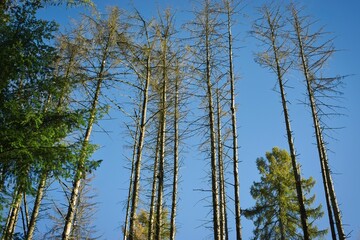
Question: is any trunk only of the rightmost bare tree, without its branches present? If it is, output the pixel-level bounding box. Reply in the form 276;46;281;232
292;8;346;240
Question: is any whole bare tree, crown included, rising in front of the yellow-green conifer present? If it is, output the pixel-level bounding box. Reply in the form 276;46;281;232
253;5;310;240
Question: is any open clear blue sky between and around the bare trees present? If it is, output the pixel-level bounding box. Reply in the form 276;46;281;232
39;0;360;240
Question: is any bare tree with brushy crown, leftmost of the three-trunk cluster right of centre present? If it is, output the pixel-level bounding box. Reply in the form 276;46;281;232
189;0;223;240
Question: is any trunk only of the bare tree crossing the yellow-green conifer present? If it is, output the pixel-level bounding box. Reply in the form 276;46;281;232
266;11;310;240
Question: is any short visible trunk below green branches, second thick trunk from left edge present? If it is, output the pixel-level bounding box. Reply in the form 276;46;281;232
26;171;48;240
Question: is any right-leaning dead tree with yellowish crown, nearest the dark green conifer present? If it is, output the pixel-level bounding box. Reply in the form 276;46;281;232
62;8;121;240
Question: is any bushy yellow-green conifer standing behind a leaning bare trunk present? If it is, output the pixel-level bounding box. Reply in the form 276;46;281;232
244;147;327;240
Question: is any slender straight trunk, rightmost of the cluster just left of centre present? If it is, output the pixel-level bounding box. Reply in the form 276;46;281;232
170;63;180;240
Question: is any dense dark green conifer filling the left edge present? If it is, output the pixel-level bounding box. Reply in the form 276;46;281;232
0;1;81;239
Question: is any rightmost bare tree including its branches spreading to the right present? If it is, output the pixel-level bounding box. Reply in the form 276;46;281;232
290;5;346;240
